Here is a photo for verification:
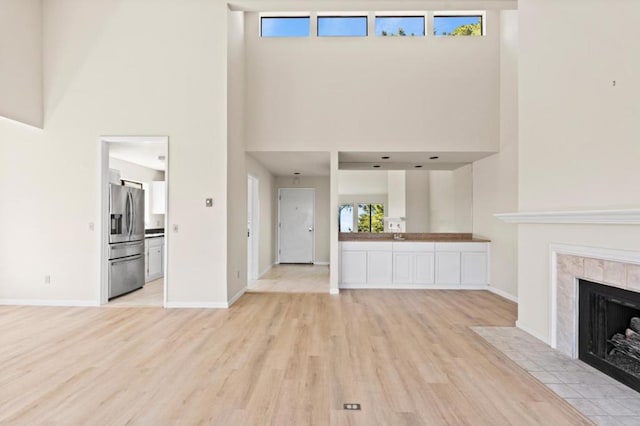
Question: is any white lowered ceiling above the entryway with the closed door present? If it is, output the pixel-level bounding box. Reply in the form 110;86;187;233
247;151;331;176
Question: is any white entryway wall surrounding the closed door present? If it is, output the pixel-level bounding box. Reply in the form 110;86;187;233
274;176;330;263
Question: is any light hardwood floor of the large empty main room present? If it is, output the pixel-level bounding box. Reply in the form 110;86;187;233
0;290;590;425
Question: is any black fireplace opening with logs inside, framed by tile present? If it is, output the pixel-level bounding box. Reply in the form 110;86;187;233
578;279;640;392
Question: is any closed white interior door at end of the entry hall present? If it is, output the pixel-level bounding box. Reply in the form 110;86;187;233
278;188;315;263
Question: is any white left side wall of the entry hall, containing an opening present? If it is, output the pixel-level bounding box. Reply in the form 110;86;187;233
247;155;278;276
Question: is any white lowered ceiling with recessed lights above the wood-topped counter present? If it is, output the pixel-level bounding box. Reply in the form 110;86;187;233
338;152;494;170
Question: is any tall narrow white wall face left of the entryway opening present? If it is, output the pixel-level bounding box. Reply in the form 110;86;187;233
227;11;248;300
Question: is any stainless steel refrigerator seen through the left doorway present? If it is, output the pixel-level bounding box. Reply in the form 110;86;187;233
108;184;144;299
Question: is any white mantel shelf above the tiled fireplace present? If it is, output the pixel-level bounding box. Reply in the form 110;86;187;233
494;209;640;225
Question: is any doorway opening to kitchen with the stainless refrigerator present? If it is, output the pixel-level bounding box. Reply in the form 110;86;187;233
98;136;169;307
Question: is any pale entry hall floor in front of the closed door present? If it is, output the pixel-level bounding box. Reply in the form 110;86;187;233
248;265;329;293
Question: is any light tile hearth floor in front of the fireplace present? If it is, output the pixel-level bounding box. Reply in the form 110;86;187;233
472;327;640;426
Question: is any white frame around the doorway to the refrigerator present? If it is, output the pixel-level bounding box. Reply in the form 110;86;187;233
97;136;170;308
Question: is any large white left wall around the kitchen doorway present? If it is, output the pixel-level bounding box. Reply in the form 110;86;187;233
0;0;230;306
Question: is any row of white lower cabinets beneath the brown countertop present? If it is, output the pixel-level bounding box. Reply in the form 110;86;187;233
340;241;489;288
